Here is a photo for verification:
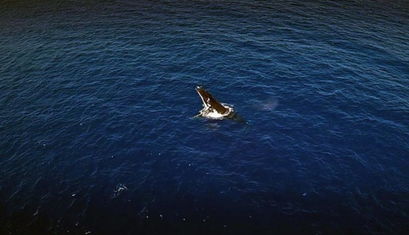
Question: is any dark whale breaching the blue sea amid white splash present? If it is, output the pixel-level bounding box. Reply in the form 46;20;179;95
196;86;235;120
